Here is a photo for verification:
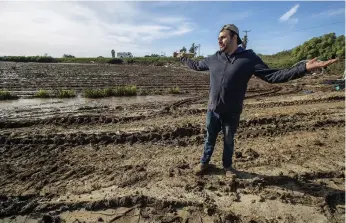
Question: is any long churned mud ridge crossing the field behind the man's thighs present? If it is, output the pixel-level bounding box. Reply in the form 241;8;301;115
0;115;345;146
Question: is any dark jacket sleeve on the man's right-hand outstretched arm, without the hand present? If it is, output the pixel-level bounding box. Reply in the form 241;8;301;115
254;55;307;83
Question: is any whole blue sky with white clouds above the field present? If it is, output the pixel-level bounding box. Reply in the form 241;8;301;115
0;1;345;57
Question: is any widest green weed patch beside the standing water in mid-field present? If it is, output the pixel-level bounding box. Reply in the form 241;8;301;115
83;86;137;98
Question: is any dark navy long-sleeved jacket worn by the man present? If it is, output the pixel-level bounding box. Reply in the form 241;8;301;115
180;47;306;115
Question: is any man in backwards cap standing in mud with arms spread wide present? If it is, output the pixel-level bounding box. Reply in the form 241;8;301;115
180;24;337;177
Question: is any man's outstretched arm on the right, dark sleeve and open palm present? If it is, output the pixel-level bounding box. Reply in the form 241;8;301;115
254;55;338;83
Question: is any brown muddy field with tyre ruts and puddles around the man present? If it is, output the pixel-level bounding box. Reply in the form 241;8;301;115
0;63;345;223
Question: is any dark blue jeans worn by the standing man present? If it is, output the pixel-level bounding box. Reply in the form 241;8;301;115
201;111;240;168
